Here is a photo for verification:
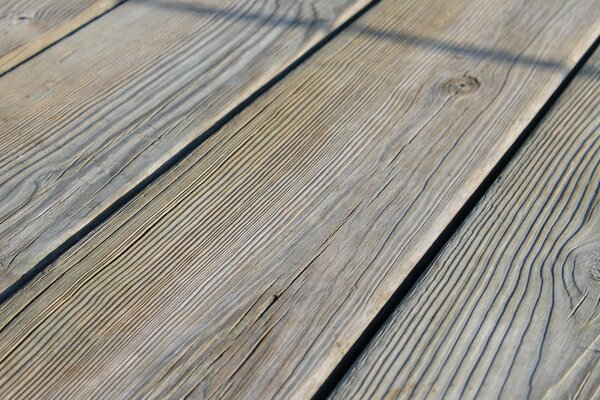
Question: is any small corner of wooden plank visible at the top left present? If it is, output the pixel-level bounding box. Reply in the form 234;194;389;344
0;0;122;75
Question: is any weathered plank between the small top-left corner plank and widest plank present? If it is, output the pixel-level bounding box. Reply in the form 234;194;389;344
0;0;368;291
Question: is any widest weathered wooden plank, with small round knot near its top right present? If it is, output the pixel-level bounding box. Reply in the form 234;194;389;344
0;0;600;398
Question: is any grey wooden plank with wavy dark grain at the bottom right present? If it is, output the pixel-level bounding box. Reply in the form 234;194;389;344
332;45;600;399
